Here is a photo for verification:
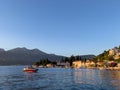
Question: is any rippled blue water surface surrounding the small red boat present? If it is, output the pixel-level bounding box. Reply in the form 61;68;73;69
0;66;120;90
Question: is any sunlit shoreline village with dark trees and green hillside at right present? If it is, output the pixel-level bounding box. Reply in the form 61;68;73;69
33;47;120;70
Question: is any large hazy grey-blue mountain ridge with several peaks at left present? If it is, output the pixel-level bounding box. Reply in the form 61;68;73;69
0;48;63;65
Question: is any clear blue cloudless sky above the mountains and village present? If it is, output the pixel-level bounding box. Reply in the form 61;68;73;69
0;0;120;56
